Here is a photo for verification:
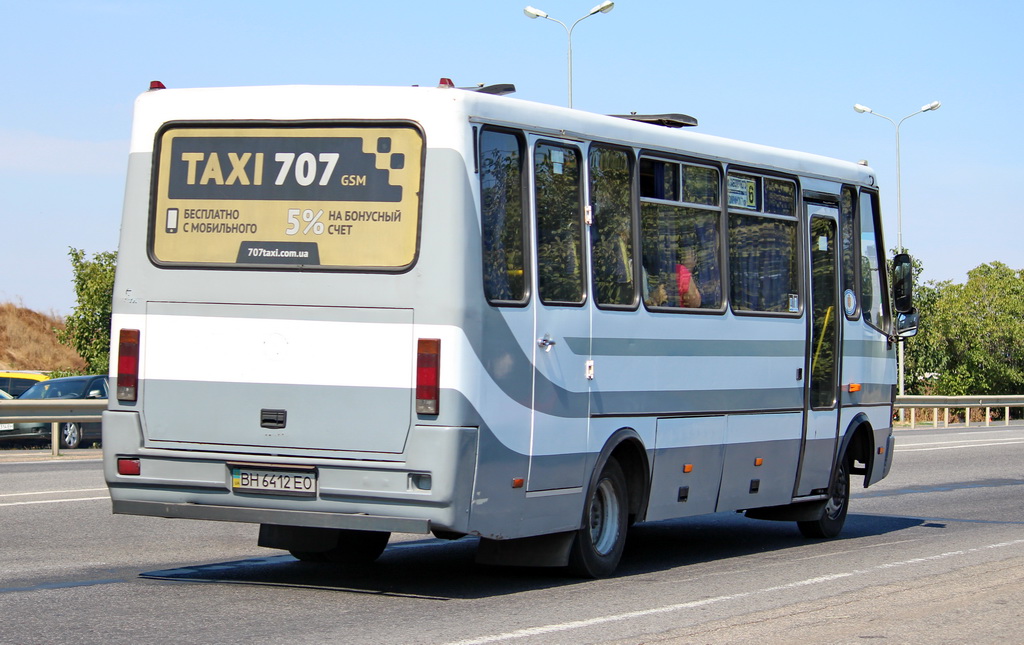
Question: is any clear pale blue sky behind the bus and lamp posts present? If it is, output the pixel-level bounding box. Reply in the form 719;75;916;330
0;0;1024;314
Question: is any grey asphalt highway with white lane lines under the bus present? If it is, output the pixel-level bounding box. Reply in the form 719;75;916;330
0;425;1024;645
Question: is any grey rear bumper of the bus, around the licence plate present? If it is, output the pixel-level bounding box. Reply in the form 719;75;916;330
103;411;478;533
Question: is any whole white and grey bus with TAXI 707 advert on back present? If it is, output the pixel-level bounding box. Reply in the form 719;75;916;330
102;81;916;577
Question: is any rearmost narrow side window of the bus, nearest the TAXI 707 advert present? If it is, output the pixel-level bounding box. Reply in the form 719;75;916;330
480;130;526;301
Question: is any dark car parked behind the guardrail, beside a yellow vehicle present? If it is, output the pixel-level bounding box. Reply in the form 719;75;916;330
0;374;108;448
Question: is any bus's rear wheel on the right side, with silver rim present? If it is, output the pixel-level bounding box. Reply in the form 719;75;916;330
569;459;629;577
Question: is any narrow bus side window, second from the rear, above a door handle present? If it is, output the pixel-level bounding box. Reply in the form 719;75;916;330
534;143;584;303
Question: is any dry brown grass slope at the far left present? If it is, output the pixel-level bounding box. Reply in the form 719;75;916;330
0;302;85;372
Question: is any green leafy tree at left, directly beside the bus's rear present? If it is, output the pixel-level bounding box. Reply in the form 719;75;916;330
57;248;118;374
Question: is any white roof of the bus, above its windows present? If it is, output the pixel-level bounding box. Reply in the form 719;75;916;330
131;85;876;186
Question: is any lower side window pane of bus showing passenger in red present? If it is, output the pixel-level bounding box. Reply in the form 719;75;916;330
640;205;722;309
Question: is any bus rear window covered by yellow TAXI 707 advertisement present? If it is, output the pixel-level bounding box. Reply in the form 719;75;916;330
150;124;423;271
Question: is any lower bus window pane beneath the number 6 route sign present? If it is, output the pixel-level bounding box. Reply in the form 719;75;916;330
729;213;798;313
